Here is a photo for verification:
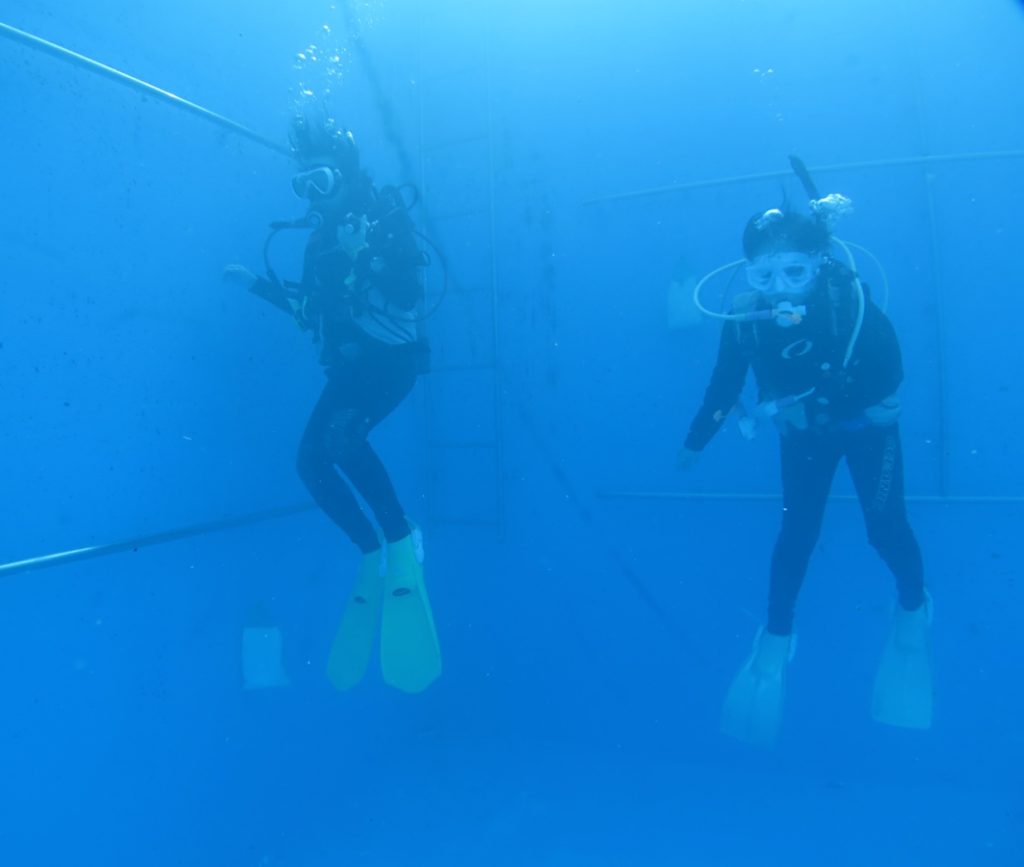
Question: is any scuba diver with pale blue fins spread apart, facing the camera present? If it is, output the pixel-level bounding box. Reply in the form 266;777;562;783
679;164;932;745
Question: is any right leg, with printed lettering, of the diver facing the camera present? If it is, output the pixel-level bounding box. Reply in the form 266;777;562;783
846;425;925;611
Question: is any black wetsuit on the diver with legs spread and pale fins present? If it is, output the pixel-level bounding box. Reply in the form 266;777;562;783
685;263;925;635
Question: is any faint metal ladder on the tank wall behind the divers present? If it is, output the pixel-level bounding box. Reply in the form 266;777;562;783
418;25;505;538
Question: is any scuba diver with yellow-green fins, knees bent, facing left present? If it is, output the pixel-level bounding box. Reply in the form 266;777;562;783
224;114;440;692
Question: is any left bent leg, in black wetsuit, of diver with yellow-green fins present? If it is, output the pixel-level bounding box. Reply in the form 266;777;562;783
296;380;380;554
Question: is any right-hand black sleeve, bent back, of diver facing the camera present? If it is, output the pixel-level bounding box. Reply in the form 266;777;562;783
833;301;903;417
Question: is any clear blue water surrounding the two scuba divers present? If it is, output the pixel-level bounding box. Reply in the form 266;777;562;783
0;0;1024;867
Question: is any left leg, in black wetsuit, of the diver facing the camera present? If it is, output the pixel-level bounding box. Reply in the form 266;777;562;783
767;432;842;636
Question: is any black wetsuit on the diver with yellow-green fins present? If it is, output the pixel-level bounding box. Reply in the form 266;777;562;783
252;185;426;553
